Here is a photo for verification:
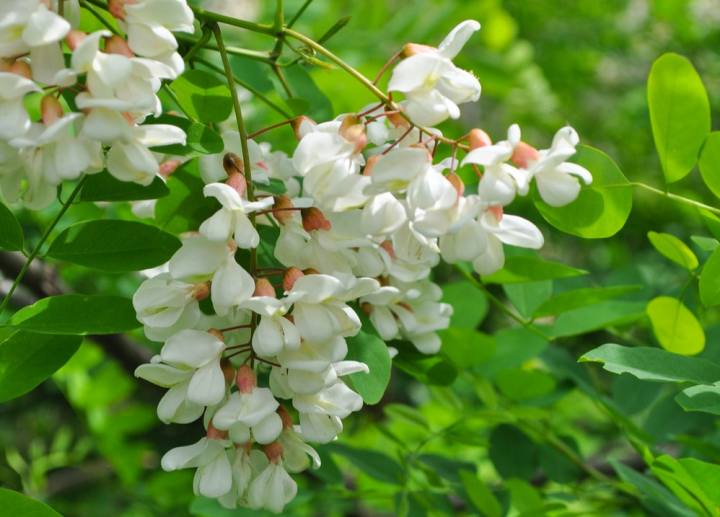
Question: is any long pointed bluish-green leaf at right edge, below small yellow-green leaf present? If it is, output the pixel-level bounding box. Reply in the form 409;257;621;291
579;343;720;384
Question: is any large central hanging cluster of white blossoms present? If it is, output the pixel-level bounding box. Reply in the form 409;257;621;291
133;21;592;512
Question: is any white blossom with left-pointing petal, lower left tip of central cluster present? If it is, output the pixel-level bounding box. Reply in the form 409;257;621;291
160;437;233;497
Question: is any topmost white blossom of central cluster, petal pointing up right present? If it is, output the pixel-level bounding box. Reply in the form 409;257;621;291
388;20;480;126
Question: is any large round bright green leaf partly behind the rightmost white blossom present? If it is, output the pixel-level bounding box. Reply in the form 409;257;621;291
533;146;632;239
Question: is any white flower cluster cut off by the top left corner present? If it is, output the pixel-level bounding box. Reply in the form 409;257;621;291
0;0;193;209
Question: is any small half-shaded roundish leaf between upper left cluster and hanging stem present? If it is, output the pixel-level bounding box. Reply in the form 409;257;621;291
170;70;232;123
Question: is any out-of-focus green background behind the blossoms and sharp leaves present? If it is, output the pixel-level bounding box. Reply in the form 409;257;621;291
0;0;720;517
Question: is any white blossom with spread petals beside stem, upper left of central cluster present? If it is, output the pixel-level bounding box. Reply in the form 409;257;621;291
200;183;273;248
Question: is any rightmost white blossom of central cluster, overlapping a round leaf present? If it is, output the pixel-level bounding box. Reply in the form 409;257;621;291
528;126;592;206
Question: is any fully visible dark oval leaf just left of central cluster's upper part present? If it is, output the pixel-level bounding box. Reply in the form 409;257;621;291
47;220;180;272
